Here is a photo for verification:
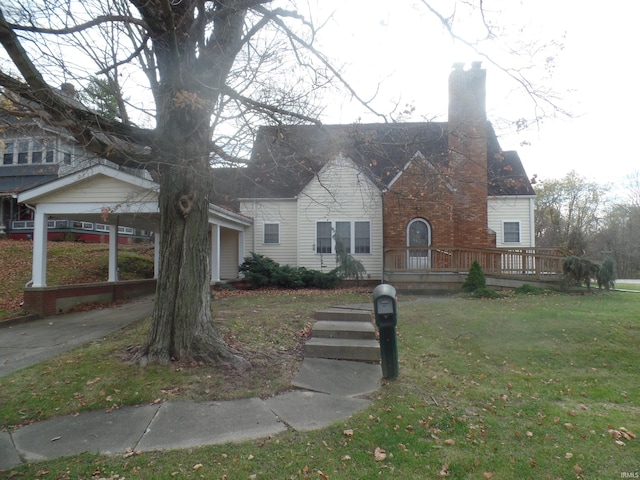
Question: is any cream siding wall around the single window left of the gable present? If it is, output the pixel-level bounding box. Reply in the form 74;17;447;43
240;199;299;267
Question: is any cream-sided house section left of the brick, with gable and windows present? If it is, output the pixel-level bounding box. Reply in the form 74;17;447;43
240;155;383;278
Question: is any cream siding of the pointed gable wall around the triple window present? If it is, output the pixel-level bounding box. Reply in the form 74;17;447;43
298;158;382;279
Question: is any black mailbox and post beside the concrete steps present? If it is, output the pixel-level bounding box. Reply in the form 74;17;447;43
373;283;398;378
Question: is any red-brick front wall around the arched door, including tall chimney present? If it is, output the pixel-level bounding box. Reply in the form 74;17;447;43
383;63;495;253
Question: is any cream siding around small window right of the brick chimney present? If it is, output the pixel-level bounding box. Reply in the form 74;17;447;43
488;196;535;248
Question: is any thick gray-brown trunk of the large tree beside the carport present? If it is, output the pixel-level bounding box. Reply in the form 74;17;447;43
127;0;248;367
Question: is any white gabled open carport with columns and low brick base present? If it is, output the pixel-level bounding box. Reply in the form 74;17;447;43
18;165;252;316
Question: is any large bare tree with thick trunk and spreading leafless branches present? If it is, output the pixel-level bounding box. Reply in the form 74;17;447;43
0;0;564;366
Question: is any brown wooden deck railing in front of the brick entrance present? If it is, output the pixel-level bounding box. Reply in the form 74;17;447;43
384;246;568;280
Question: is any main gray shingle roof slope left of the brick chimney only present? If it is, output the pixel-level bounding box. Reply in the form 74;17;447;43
241;123;447;197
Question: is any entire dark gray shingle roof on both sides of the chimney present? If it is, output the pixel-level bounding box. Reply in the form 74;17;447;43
214;122;535;203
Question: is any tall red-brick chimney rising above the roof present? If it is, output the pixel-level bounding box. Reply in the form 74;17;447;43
448;62;495;247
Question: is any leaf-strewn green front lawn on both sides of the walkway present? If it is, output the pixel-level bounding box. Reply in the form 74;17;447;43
0;292;640;479
